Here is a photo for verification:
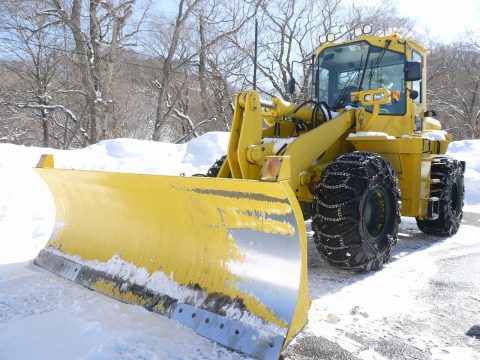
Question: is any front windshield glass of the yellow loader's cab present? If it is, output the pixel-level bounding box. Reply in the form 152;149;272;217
316;41;405;115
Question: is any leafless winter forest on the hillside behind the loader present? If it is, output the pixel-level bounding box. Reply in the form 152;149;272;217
0;0;480;149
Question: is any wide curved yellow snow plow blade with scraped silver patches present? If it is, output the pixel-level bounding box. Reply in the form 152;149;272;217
35;159;309;359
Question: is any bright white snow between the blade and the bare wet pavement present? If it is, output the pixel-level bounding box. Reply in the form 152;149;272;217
305;218;480;359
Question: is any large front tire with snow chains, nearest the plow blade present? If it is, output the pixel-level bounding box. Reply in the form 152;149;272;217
312;151;400;272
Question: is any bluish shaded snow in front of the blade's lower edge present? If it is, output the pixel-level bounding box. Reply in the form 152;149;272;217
0;262;240;360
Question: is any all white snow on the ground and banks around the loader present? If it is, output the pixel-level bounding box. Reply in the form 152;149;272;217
0;132;480;360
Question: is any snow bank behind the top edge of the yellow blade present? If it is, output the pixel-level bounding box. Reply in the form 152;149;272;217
0;132;229;176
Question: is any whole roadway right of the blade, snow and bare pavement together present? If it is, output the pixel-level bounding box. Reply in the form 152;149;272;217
285;217;480;360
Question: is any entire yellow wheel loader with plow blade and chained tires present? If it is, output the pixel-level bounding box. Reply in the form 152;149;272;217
35;35;465;359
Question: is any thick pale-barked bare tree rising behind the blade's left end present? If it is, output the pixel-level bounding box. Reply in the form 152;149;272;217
47;0;148;143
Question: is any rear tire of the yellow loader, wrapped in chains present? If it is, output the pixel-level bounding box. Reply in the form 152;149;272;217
416;157;465;236
